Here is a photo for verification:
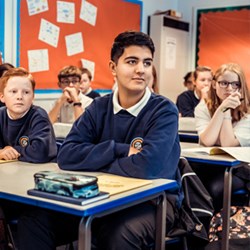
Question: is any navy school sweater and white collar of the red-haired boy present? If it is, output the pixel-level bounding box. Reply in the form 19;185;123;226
0;105;57;163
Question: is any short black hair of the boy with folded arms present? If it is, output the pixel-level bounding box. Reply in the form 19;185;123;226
111;31;155;63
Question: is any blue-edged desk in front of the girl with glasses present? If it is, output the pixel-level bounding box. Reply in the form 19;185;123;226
181;144;244;250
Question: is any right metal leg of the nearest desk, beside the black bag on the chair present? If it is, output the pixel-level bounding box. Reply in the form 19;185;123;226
155;192;167;250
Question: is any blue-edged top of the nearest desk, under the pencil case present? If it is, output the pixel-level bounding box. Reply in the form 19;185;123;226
0;161;177;216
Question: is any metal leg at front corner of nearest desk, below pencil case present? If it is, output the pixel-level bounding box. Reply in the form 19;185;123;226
78;216;93;250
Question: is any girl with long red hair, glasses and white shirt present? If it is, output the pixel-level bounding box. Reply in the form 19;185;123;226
195;63;250;211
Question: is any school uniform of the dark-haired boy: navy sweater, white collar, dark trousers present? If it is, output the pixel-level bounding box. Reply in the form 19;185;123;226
20;88;180;250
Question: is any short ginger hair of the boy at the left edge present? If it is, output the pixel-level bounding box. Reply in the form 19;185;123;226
0;67;36;93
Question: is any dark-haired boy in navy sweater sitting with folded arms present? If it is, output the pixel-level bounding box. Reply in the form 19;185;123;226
19;31;180;250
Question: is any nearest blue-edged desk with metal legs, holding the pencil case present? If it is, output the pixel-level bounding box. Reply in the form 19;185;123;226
0;161;177;250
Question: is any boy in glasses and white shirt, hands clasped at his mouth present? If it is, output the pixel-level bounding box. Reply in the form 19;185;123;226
49;66;92;123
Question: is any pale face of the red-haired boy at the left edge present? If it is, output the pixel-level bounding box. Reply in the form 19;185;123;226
1;76;34;119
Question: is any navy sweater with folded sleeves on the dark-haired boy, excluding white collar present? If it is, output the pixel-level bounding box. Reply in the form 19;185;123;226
58;95;180;179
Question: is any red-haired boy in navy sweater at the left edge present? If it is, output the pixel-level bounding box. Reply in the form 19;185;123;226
0;68;57;163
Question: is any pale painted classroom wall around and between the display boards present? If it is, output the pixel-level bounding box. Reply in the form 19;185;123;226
1;0;250;109
